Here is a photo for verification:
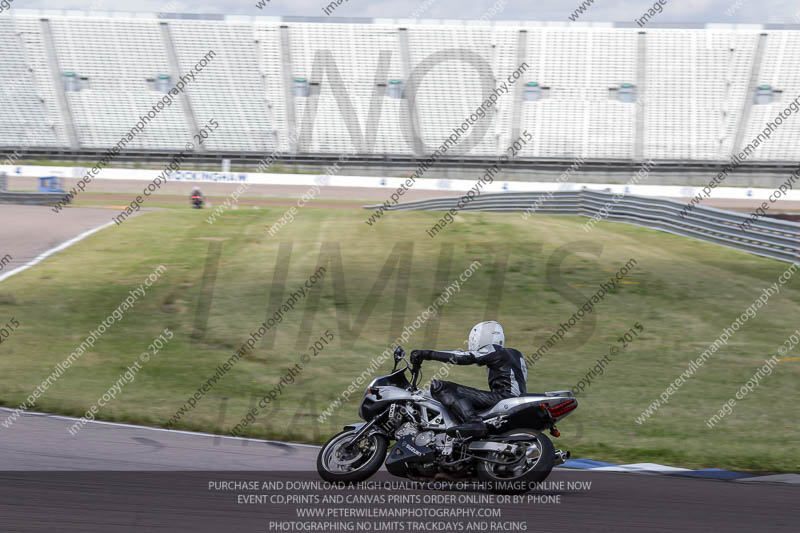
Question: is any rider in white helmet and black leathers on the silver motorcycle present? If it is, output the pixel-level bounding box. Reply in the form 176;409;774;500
411;320;528;437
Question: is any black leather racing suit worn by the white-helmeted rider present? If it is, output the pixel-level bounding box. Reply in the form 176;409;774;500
426;344;528;422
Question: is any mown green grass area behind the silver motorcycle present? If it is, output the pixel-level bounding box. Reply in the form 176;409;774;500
0;206;800;472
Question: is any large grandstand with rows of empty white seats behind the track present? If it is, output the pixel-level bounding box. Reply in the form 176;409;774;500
0;9;800;166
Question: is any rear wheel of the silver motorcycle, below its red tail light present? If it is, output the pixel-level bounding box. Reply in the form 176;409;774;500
476;429;556;494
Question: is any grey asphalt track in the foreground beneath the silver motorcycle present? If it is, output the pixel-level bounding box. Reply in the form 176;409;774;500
0;410;800;532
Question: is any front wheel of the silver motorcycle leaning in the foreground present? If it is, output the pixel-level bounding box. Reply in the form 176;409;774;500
317;430;389;483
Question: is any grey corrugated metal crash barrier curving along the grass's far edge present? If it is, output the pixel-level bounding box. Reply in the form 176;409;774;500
366;190;800;263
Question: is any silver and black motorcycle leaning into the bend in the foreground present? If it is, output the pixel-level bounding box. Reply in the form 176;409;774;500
317;347;578;494
